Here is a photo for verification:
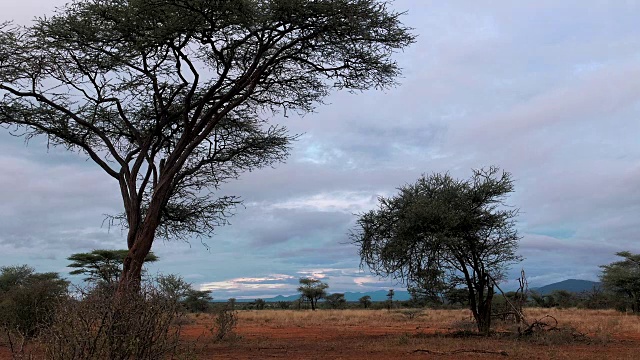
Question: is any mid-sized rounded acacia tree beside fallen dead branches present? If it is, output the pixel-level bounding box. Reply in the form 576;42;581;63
350;167;520;334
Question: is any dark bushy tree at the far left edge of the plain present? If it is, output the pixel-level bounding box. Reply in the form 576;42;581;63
0;265;69;338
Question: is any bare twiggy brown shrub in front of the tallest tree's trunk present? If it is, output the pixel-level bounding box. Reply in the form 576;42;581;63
41;283;184;360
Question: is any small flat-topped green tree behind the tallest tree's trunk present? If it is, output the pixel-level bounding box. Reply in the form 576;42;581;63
67;250;158;286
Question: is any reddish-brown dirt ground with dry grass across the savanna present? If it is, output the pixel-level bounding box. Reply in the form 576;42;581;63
0;309;640;360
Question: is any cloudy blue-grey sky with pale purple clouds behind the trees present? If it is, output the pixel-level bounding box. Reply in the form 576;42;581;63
0;0;640;299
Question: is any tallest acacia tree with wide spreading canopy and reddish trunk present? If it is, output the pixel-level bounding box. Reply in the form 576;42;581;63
0;0;414;288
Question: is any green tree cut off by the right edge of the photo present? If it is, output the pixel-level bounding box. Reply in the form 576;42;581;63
600;251;640;313
